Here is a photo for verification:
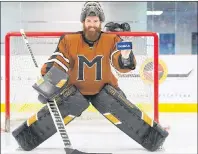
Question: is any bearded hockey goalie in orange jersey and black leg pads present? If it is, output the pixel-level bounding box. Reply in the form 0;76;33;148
12;2;168;151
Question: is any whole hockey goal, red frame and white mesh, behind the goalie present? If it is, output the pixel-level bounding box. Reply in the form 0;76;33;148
1;32;159;132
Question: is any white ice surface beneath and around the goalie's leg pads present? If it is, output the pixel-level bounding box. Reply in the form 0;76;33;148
1;113;197;154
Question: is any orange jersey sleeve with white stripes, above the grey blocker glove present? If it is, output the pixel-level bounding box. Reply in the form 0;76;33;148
41;35;70;76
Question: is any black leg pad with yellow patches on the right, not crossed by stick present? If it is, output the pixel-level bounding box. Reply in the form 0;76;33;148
92;85;168;151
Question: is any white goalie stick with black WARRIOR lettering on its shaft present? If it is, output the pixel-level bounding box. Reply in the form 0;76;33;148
20;29;112;154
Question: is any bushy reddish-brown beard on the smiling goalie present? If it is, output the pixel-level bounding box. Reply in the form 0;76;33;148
83;23;101;41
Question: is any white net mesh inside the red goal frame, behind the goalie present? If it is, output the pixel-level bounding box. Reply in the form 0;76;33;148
3;34;157;129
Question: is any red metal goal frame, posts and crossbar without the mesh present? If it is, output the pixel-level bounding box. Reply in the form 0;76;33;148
5;32;159;131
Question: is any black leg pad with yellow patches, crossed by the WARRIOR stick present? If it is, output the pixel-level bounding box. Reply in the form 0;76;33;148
12;86;89;151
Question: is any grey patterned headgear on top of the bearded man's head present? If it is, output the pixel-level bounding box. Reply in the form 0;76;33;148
80;2;105;22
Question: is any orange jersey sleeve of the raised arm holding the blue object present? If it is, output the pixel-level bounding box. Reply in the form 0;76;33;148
110;35;136;73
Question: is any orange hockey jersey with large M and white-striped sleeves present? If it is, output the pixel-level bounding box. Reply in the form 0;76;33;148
41;33;131;95
